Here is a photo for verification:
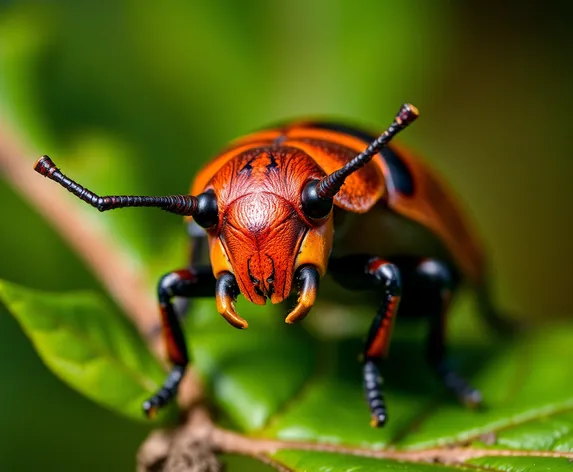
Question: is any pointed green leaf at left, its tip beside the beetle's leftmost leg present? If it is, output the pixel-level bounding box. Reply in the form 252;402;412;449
0;281;172;421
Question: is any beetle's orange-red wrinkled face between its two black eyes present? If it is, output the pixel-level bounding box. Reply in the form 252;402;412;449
199;147;332;304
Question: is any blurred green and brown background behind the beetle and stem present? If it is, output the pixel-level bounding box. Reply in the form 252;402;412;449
0;0;573;472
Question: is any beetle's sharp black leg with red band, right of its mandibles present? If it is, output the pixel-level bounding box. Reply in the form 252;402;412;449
329;256;401;427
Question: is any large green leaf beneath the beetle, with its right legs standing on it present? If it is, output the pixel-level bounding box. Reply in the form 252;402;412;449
184;292;573;470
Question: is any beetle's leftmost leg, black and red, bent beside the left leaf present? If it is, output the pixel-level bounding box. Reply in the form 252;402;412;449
143;267;215;416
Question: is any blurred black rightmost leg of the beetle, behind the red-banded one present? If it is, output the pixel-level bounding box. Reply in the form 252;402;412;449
415;259;482;407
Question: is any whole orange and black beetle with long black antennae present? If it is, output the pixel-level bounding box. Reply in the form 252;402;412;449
34;104;505;427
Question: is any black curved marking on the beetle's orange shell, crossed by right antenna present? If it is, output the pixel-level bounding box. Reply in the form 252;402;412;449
308;122;415;195
